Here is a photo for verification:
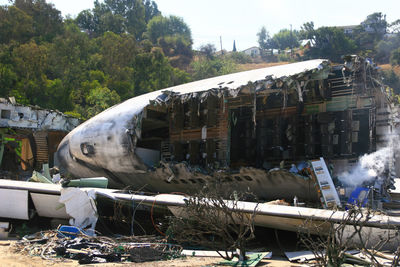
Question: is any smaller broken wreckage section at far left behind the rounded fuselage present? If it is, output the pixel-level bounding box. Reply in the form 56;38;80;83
0;98;80;180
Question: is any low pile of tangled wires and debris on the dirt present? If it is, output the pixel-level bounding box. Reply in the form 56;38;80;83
13;230;182;264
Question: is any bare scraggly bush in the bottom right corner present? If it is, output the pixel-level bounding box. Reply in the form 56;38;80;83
300;206;399;266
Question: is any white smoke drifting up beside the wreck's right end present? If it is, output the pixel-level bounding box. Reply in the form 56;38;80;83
338;147;392;188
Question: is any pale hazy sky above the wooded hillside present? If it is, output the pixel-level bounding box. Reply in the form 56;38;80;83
0;0;400;51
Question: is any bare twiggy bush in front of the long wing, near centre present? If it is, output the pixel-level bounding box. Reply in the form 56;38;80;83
168;183;258;260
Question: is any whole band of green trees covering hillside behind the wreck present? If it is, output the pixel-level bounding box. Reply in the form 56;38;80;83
0;0;400;119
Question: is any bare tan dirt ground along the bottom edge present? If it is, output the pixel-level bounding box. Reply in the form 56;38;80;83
0;241;300;267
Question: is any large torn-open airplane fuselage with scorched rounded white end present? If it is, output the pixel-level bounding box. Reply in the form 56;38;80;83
58;57;390;200
